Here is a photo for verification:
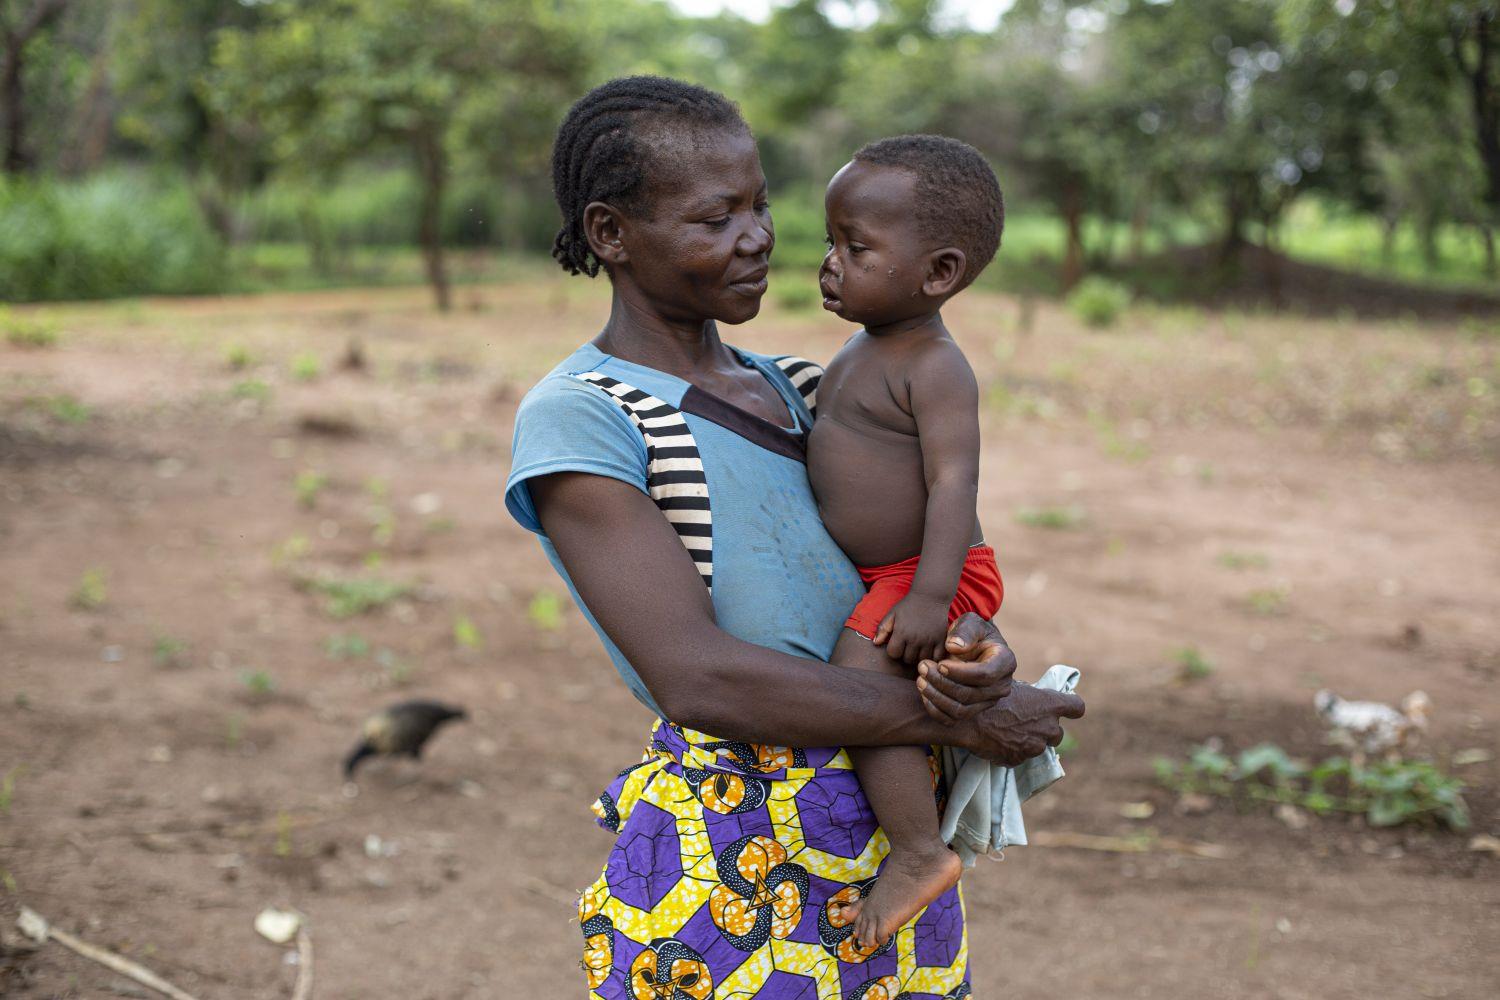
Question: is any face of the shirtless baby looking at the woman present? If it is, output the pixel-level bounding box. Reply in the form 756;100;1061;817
818;160;935;327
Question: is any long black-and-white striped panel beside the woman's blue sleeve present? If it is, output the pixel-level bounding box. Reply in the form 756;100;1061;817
576;372;714;594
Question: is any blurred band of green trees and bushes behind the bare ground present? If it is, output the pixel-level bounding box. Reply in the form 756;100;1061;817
0;0;1500;306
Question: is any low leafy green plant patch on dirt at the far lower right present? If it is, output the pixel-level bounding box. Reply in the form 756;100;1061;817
1154;744;1469;831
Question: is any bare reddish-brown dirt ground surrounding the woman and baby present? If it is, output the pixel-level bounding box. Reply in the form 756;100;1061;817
0;270;1500;1000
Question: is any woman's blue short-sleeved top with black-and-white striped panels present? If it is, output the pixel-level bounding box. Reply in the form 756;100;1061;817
506;345;864;715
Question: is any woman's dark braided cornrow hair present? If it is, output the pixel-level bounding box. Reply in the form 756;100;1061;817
552;76;746;277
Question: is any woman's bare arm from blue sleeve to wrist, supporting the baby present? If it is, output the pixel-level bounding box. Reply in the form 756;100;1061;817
528;472;978;747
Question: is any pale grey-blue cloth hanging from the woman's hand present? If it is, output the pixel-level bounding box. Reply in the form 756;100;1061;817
939;664;1082;868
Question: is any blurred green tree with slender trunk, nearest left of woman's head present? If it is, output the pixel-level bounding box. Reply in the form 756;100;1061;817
209;0;579;309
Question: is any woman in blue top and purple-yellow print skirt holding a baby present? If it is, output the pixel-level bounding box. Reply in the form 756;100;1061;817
506;76;1082;1000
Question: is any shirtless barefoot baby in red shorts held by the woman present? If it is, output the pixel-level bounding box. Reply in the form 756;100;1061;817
807;135;1005;954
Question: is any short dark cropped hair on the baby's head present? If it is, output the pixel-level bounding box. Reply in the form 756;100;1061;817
854;135;1005;288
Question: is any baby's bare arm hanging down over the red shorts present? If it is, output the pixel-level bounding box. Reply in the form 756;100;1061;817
875;340;980;663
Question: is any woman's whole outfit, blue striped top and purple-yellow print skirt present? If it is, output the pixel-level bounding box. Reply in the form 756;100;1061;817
506;348;969;1000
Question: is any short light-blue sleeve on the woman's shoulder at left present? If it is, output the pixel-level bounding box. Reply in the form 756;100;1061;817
506;376;647;534
